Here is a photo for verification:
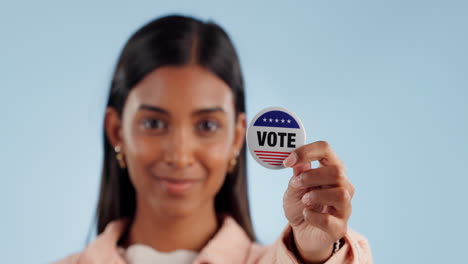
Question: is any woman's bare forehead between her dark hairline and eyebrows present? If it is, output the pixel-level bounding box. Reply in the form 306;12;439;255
128;64;234;111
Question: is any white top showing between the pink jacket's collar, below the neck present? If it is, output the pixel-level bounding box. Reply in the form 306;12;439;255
119;244;198;264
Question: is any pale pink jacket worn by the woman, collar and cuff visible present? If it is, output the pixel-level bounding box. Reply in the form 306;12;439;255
55;217;372;264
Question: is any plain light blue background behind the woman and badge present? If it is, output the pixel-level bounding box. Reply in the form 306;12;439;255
0;0;468;263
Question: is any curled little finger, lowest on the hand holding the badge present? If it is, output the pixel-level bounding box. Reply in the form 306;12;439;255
303;208;347;239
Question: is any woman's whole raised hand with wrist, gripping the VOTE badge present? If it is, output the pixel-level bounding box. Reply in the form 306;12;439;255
283;141;354;263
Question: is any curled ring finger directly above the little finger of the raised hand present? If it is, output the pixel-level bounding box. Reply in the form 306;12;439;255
302;187;351;219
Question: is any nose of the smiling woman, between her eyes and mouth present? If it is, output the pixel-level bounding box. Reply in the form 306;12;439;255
163;129;194;168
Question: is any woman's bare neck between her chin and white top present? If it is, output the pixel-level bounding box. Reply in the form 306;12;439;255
125;199;218;252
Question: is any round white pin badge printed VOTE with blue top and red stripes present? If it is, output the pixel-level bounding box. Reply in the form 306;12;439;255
247;107;306;169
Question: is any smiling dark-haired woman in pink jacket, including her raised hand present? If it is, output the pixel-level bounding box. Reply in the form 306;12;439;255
54;16;372;263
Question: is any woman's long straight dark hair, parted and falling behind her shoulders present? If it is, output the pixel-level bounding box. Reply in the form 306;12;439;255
96;15;255;241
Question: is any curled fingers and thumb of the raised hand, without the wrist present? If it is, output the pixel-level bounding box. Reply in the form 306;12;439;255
284;141;354;241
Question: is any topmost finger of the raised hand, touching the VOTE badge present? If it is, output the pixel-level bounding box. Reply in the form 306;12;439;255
283;141;341;167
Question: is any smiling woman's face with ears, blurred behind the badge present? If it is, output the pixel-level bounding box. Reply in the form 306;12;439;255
106;65;245;215
